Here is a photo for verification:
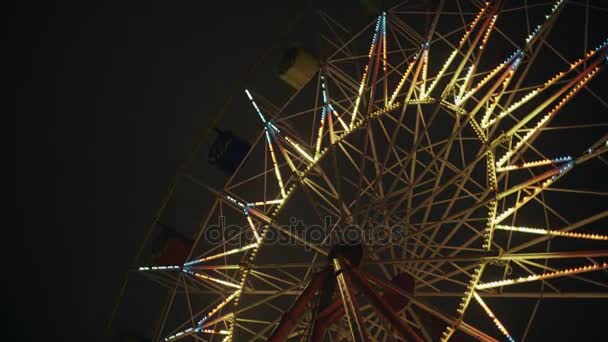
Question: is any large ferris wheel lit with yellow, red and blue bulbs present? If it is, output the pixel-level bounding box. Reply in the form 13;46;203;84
126;0;608;341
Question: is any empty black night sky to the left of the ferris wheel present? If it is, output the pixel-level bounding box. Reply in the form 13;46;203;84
16;0;604;341
